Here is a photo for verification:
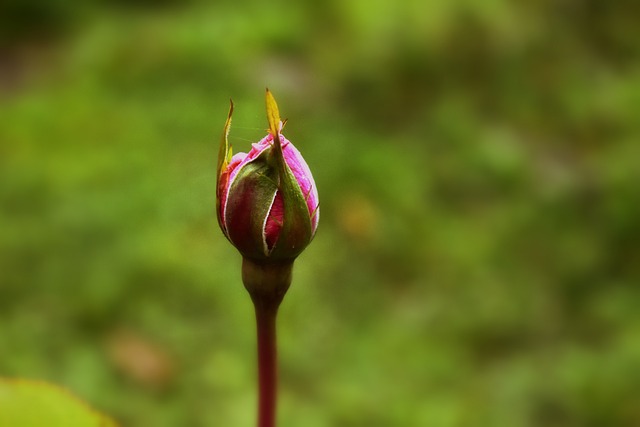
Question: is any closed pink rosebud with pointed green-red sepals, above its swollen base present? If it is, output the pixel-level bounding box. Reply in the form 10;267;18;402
216;89;319;261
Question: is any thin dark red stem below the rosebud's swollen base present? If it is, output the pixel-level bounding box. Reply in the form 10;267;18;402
254;300;279;427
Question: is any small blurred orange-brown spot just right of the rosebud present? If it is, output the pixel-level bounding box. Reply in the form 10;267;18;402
338;193;378;242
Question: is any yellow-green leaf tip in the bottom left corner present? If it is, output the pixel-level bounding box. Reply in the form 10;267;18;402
0;380;116;427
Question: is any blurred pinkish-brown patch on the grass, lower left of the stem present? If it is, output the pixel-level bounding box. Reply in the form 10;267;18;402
107;329;175;389
